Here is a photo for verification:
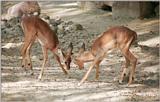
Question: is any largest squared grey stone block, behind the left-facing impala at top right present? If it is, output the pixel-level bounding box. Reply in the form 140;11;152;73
112;1;154;18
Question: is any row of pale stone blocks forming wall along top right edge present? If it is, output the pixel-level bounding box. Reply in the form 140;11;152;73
78;1;159;18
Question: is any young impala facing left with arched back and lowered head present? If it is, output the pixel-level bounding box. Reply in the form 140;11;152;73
74;26;137;85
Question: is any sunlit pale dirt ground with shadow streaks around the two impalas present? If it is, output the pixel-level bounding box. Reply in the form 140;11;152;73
1;1;160;102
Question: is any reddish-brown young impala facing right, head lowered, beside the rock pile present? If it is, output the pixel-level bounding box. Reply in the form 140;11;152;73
21;15;72;80
